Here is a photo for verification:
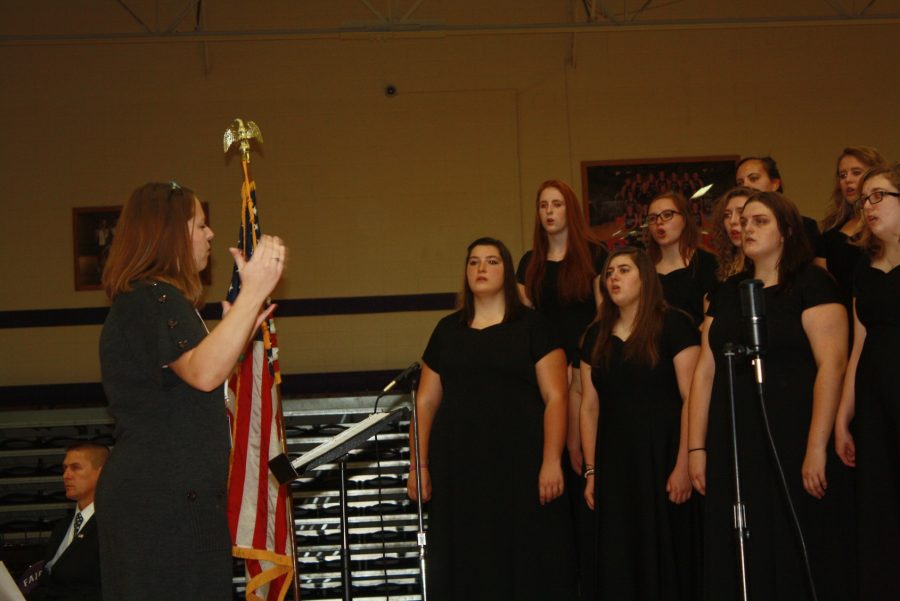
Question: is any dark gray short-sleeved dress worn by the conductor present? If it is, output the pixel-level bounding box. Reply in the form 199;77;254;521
96;282;232;601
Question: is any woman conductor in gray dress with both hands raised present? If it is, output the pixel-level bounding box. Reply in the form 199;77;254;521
96;183;286;601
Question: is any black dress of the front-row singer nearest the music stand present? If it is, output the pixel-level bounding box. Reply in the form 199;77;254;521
423;308;576;601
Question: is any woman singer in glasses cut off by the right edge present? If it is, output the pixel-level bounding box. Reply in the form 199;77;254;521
835;165;900;599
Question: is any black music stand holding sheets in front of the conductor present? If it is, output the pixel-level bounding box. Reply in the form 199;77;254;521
269;407;409;601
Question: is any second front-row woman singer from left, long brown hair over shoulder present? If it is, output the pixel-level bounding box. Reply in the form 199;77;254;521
581;247;700;601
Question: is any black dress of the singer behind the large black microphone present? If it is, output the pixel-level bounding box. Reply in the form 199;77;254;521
703;264;856;601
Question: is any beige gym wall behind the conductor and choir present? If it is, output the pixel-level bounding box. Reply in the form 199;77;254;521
0;12;900;385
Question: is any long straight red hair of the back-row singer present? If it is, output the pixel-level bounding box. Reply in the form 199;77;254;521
525;179;597;307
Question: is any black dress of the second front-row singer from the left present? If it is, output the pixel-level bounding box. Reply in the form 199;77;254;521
583;309;700;601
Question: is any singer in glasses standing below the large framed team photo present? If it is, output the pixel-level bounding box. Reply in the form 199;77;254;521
647;192;718;327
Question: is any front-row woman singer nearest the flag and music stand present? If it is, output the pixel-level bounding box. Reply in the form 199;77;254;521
408;238;576;601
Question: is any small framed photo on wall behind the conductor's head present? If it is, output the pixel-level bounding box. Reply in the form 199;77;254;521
72;202;212;290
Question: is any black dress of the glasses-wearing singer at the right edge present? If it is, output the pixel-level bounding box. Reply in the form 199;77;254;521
851;259;900;599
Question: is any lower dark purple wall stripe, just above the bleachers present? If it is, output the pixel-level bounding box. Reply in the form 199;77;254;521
0;368;412;410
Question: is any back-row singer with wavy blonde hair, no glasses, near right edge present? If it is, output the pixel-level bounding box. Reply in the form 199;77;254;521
815;146;884;312
